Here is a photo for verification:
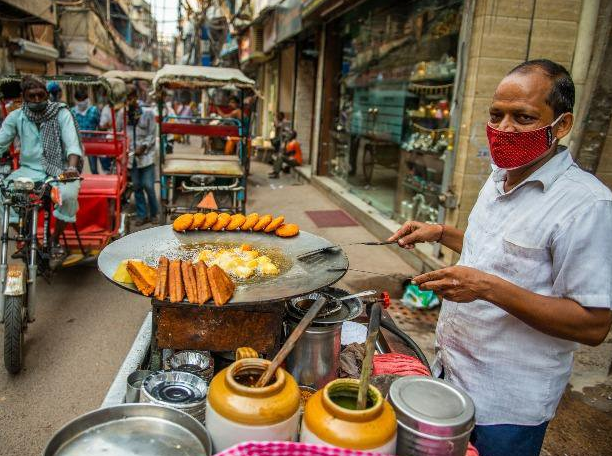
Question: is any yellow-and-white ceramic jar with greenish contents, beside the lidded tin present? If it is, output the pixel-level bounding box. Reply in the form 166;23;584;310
300;378;397;454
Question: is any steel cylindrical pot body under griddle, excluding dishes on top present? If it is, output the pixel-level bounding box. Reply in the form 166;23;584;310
287;321;342;389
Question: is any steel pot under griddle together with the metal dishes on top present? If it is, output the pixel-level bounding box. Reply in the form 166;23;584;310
285;287;362;389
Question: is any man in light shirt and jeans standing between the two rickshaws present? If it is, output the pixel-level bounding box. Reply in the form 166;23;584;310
126;85;159;226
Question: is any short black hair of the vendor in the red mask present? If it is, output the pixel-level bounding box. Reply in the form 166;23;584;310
508;59;576;118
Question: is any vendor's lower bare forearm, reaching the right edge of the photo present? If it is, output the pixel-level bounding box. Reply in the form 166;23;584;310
482;274;612;345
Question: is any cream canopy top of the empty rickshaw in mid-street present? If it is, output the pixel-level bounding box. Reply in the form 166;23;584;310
153;65;255;92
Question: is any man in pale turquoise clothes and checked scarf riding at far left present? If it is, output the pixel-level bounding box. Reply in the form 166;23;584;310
0;75;83;261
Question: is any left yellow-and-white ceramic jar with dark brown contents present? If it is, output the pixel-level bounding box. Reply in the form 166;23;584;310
206;358;300;452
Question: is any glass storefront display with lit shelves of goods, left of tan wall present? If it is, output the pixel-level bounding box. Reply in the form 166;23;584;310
328;0;462;221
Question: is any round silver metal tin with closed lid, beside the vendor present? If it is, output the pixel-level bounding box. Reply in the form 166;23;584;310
389;376;474;456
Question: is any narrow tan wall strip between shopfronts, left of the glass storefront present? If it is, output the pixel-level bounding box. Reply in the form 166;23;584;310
294;59;316;163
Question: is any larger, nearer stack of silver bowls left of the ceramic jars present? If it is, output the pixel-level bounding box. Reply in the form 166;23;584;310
140;371;208;423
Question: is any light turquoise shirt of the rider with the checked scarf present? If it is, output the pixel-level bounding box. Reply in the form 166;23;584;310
0;109;83;180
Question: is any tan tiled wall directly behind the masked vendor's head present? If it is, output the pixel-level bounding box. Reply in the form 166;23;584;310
447;0;584;235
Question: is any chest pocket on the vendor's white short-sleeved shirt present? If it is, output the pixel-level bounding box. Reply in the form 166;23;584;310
501;233;552;280
